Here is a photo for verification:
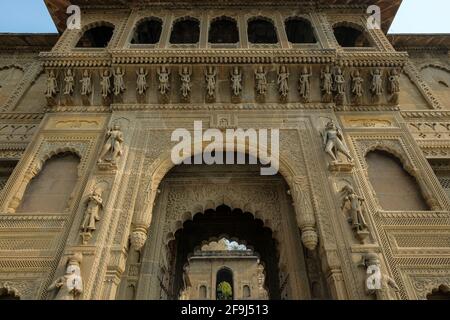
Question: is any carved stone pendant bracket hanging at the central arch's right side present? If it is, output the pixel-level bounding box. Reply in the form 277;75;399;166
291;177;319;250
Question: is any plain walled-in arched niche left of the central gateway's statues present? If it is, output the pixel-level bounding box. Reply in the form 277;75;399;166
16;152;80;213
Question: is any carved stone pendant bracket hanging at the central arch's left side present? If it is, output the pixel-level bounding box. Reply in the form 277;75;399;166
130;186;159;251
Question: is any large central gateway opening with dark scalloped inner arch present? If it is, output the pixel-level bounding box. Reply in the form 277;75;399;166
124;154;329;299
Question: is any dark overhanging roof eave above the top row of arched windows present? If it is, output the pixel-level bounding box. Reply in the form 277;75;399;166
44;0;402;32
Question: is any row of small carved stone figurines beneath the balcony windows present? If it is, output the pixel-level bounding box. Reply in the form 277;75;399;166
45;66;400;103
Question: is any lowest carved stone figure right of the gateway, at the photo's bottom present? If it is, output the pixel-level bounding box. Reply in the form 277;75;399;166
363;253;400;300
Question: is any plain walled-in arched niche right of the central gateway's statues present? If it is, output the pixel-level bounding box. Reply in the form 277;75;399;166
366;150;429;211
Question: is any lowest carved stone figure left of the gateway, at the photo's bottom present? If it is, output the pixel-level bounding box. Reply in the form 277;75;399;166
47;252;83;300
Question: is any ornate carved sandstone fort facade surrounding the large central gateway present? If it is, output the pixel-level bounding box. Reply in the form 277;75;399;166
0;0;450;300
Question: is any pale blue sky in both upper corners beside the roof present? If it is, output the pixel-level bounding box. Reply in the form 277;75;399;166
0;0;450;33
